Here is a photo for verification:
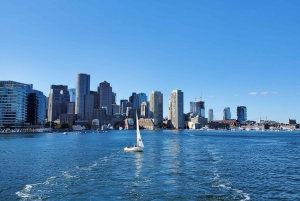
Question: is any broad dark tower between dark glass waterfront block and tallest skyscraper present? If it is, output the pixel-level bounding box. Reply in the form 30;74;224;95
48;85;70;121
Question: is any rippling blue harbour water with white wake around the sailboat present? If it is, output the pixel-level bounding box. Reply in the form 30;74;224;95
0;130;300;200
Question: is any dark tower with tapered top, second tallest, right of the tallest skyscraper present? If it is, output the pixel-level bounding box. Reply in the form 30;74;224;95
98;81;112;115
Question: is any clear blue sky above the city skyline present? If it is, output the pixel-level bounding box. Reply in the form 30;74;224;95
0;0;300;123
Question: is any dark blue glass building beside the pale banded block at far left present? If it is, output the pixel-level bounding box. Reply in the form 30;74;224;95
26;90;46;125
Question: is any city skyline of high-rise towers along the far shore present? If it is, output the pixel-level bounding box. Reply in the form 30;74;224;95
0;73;253;129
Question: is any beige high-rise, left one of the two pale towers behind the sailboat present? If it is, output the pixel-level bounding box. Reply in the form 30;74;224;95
149;91;163;124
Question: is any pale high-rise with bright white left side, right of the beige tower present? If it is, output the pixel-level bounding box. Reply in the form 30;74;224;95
168;90;184;129
